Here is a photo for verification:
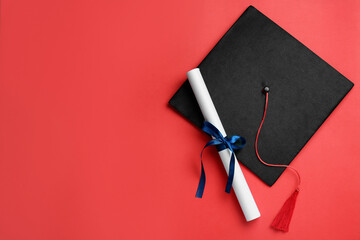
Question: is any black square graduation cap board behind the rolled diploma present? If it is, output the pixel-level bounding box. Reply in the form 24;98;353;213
169;6;353;186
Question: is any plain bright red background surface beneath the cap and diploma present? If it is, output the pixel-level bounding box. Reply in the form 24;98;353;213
0;0;360;240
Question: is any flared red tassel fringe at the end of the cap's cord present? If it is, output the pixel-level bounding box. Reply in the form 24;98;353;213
271;189;299;232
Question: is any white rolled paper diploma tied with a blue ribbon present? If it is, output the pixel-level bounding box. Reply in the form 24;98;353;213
187;68;260;221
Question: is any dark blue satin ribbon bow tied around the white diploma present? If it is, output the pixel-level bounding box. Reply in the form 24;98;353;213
195;121;246;198
